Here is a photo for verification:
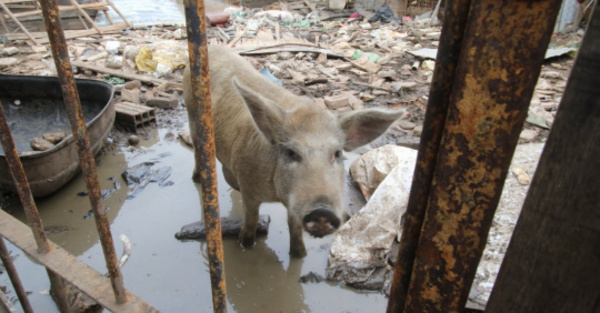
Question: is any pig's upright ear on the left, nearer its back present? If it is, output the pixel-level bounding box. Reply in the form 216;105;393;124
232;78;285;144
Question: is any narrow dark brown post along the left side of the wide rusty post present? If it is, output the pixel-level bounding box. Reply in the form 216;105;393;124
387;0;471;313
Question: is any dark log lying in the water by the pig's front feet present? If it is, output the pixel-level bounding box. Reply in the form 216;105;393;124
175;215;271;240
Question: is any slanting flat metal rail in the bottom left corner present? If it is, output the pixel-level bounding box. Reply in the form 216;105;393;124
0;210;159;313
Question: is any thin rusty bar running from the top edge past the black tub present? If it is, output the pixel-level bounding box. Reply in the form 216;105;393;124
40;0;127;303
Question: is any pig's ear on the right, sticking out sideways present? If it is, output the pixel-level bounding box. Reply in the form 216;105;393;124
339;109;404;151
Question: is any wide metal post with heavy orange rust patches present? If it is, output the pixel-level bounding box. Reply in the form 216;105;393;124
404;0;561;313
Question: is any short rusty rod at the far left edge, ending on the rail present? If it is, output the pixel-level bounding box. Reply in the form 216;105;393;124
0;103;50;253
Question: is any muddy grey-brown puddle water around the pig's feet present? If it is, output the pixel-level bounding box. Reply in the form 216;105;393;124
0;122;387;313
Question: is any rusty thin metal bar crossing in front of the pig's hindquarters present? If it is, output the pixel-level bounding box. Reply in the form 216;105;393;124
184;0;227;312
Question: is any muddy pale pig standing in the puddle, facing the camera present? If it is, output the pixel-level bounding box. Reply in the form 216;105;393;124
183;46;403;258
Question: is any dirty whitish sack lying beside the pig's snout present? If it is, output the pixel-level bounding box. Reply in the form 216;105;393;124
326;146;417;284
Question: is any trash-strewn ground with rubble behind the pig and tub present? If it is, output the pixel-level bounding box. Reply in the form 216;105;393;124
0;1;582;310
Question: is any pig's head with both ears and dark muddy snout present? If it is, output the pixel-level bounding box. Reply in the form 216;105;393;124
234;79;402;237
